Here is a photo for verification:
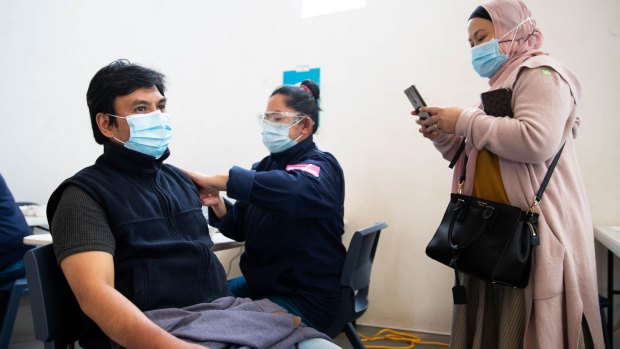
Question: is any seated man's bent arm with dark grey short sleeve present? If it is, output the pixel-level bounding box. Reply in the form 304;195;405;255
51;186;204;349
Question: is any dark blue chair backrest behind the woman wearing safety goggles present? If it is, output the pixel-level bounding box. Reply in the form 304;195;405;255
325;222;387;338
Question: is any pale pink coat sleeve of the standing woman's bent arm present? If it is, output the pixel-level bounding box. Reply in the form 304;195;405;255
456;67;575;163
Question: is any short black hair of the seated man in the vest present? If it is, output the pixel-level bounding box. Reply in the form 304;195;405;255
86;59;166;144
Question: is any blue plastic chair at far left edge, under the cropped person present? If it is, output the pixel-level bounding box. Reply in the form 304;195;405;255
0;272;28;349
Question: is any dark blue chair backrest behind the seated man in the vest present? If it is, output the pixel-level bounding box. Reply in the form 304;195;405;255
24;245;82;349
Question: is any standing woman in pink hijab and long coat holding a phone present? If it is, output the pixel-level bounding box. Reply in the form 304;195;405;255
412;0;603;349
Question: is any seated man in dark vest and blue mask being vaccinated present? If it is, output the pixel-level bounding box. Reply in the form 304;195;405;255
47;60;331;349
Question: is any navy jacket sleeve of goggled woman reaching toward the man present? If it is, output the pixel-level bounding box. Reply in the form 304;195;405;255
227;162;343;218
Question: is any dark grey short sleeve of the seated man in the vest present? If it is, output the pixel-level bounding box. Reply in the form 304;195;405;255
50;186;116;263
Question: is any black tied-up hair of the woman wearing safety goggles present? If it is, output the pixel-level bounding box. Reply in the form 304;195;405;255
271;80;321;133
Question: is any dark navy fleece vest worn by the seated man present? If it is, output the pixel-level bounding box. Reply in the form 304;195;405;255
47;142;230;346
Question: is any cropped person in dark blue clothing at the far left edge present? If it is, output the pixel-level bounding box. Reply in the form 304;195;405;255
0;175;32;282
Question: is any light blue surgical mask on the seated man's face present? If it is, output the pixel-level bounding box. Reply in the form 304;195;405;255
110;110;172;159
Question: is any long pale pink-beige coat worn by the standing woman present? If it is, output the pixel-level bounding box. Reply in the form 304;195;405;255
434;55;604;349
